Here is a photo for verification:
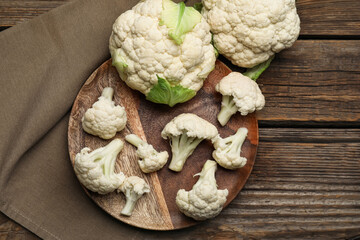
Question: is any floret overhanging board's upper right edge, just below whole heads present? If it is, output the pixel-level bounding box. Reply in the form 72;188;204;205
215;72;265;126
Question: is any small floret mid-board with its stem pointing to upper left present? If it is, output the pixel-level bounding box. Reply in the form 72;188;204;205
125;134;169;173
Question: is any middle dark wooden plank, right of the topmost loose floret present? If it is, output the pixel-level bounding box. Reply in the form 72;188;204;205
220;40;360;126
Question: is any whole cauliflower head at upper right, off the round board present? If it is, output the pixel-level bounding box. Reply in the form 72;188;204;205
202;0;300;68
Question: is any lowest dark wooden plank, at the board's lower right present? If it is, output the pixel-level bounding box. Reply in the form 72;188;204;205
0;128;360;239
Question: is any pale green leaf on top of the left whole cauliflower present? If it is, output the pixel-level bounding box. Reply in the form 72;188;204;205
159;0;202;45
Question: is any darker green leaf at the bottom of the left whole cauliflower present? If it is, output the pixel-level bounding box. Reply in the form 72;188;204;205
146;76;196;107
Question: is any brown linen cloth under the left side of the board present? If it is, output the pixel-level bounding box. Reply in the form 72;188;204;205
0;0;197;239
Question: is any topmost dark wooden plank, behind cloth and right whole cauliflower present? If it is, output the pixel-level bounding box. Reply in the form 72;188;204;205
0;0;360;36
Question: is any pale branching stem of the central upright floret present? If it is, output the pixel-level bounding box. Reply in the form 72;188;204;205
169;134;203;172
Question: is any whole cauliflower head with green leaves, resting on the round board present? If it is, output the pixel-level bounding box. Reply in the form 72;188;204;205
109;0;216;106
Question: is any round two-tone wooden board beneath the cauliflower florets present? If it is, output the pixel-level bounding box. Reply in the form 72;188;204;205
68;59;258;230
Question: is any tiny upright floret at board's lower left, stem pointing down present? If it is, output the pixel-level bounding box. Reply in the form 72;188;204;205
118;176;150;216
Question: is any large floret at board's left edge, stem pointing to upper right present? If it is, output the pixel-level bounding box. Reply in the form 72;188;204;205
74;139;125;194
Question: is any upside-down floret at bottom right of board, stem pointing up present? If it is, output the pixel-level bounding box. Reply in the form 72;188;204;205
176;160;228;221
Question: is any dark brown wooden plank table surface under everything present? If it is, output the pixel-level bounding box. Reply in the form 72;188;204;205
0;0;360;240
